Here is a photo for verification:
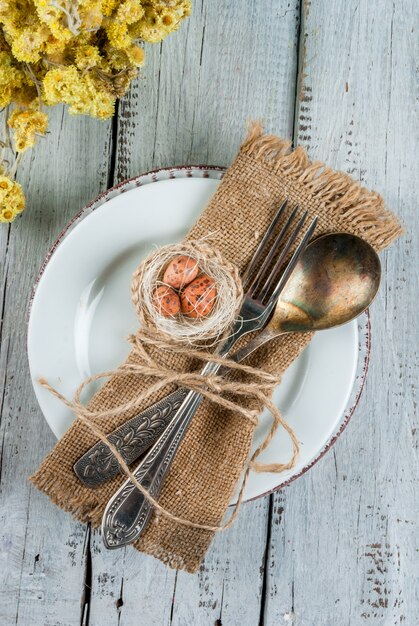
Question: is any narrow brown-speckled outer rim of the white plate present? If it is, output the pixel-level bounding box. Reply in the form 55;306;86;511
26;165;371;506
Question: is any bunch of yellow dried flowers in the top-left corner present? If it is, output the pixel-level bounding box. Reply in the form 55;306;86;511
0;0;191;221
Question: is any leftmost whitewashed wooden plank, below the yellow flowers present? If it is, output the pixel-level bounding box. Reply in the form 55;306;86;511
0;108;110;626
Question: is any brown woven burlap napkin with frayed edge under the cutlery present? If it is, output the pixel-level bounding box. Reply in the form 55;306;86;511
31;124;401;572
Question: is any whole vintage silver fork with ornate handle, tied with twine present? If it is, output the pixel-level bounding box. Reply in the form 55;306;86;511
102;202;317;549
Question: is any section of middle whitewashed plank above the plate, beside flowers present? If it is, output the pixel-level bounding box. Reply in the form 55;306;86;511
116;0;299;180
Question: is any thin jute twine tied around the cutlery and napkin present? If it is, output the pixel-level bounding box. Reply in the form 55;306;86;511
39;328;299;532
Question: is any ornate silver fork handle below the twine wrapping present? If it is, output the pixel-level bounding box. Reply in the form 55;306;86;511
102;386;207;549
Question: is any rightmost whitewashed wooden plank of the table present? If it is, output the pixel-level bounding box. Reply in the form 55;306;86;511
261;0;419;626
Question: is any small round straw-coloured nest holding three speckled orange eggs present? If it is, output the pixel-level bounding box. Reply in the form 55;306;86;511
131;240;243;345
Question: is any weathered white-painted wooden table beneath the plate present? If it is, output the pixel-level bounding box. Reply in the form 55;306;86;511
0;0;419;626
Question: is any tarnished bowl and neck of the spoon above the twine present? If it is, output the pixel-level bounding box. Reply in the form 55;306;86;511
234;233;381;361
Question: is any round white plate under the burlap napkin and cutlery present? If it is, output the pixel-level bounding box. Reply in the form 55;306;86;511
28;167;369;499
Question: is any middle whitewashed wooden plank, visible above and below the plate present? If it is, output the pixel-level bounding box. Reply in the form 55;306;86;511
86;0;299;626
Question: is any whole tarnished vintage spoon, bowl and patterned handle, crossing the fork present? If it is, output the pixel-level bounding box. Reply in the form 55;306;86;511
74;233;381;488
